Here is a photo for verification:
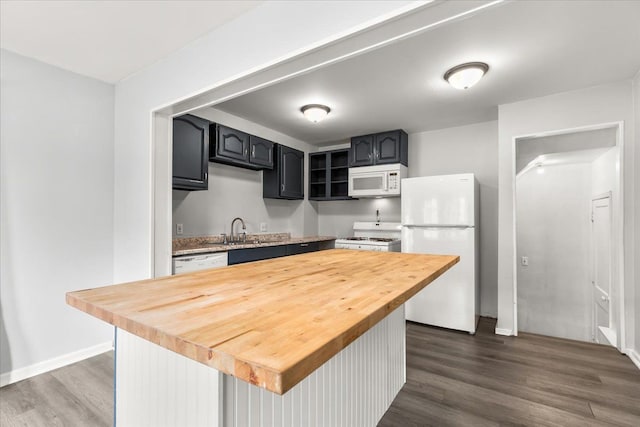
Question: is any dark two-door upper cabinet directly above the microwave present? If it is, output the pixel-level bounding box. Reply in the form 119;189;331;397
350;129;409;166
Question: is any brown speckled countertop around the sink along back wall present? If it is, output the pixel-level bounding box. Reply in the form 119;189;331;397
172;233;336;256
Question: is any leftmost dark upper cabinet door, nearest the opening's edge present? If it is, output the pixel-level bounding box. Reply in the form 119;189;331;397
173;115;209;190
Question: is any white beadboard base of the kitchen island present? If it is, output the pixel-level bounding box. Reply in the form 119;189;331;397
115;306;406;427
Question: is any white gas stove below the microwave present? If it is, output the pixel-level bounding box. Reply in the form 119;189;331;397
336;222;402;252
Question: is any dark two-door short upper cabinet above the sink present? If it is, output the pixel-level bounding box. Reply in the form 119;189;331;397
209;124;273;170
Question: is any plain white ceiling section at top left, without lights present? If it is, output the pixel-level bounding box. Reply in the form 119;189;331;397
0;0;261;83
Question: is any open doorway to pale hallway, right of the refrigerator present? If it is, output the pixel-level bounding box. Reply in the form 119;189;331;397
514;123;624;349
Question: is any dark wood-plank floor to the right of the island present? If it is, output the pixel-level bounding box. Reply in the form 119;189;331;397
379;318;640;427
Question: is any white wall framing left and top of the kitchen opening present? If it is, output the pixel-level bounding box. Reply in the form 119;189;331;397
114;1;412;282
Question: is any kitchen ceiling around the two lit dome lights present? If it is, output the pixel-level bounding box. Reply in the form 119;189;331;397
214;1;640;145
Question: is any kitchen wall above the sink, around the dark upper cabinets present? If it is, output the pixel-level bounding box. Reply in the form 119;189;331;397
172;108;317;237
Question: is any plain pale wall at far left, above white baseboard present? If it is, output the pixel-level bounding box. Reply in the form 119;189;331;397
0;50;114;380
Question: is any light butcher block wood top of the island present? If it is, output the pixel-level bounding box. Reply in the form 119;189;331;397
67;249;459;394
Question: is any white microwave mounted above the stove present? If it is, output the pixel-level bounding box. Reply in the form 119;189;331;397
349;163;407;197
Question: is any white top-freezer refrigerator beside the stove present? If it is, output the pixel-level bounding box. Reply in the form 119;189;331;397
401;173;480;334
